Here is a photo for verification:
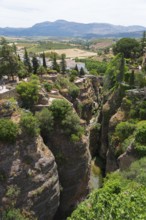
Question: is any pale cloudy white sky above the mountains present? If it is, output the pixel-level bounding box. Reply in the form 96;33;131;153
0;0;146;27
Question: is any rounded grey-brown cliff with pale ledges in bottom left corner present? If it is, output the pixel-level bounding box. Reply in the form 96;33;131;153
0;137;60;220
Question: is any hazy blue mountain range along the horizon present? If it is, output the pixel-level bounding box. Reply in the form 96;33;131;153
0;20;146;38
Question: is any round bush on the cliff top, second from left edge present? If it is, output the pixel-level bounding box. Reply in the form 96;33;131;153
20;113;40;137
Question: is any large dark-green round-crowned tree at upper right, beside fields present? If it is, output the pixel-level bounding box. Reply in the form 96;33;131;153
113;38;140;58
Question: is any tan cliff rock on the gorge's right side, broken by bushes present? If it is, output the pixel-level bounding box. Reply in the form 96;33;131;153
106;89;146;172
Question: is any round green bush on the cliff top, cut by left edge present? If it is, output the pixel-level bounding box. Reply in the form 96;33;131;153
0;119;18;143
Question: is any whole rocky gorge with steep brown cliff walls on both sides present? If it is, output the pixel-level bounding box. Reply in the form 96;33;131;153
0;72;145;220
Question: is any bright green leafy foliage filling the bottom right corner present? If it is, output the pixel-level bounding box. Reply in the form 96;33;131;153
68;159;146;220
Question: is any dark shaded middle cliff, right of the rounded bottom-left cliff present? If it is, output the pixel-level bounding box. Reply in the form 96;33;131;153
48;129;91;220
